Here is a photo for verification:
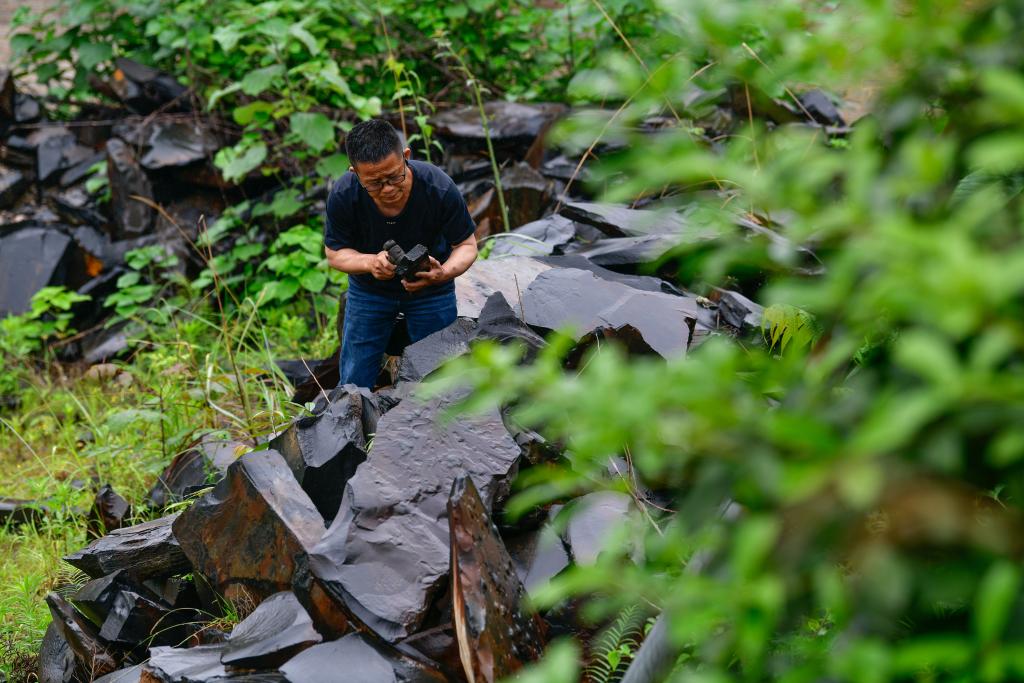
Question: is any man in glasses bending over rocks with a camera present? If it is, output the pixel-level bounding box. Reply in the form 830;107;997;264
324;119;476;388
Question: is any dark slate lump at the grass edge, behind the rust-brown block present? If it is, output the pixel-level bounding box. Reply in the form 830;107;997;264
146;436;249;508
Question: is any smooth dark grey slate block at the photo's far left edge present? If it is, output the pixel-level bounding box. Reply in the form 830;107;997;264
0;227;72;317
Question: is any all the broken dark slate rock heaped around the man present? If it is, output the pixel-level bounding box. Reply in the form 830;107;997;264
12;61;843;683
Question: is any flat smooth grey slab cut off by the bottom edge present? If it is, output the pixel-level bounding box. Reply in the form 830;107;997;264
281;633;449;683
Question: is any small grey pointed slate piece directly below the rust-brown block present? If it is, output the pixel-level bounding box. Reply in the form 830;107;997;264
220;592;323;669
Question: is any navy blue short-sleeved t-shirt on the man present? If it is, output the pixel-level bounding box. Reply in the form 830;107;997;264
324;161;476;296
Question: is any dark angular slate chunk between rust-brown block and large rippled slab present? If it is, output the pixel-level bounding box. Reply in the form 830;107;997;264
269;385;380;519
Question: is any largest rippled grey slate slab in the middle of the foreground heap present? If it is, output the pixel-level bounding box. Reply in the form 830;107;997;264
309;394;520;641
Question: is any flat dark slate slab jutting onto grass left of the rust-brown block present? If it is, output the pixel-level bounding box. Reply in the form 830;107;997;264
65;514;190;579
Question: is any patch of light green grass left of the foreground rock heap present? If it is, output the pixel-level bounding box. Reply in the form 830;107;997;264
0;296;337;676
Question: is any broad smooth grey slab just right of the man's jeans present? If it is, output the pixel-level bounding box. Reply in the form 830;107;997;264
522;268;697;357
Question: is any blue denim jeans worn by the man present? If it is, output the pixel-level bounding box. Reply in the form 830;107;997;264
340;280;457;389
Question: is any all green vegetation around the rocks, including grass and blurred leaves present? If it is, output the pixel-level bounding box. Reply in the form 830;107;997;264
0;0;1024;682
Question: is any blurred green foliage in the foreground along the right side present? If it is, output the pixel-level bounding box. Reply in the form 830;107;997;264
438;0;1024;683
